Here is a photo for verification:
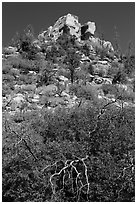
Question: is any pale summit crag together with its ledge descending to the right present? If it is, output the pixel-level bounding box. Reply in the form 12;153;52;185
38;14;114;55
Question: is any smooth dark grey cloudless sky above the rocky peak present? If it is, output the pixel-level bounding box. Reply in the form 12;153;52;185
2;2;135;53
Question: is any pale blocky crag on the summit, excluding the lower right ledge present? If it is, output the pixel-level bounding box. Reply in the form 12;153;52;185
38;14;96;41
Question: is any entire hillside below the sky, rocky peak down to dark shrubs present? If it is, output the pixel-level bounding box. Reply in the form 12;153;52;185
2;14;135;202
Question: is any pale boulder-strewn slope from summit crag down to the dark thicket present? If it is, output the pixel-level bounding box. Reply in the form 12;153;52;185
3;14;134;115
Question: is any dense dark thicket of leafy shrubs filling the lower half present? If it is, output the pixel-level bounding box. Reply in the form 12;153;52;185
3;101;134;202
